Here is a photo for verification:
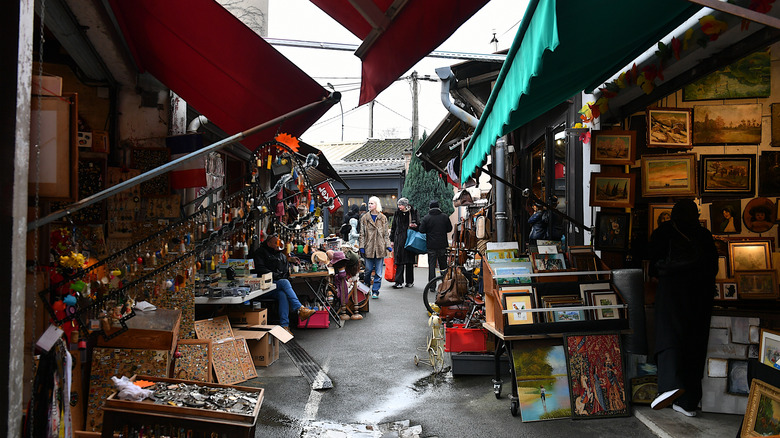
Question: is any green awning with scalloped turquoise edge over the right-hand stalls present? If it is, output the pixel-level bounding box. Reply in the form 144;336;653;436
460;0;701;182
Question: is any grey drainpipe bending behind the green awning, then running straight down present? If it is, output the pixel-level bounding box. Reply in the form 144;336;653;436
436;67;507;242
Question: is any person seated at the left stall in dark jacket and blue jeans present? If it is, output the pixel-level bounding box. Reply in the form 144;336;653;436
250;234;315;332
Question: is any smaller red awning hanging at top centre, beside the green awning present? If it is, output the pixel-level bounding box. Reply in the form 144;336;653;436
311;0;488;105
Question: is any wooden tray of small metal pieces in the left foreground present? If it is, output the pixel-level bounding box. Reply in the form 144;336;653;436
105;375;265;426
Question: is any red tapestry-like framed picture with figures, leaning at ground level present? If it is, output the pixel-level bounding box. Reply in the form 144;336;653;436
563;333;630;419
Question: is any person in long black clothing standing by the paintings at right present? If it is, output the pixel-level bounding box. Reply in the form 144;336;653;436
650;200;718;416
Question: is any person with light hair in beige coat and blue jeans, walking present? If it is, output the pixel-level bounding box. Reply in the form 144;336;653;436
358;196;393;298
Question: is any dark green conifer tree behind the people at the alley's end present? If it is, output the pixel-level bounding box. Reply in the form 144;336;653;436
401;133;455;219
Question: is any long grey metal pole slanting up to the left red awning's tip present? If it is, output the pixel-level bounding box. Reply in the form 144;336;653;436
27;92;341;232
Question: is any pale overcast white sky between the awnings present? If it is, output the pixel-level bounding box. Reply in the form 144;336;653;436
268;0;528;144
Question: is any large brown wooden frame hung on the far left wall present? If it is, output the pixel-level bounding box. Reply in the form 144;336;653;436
27;93;79;202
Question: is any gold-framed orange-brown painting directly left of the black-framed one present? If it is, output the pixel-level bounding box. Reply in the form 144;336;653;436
642;154;696;197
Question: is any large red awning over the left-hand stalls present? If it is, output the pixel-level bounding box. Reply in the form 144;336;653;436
109;0;336;149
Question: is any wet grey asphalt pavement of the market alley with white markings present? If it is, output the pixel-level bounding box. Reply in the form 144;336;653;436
242;268;734;438
